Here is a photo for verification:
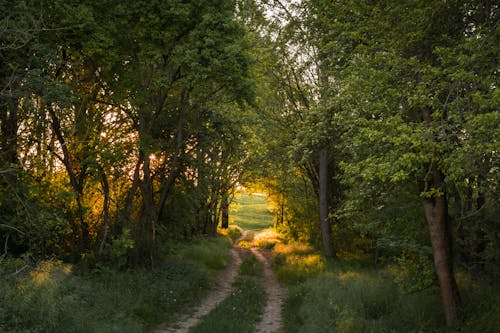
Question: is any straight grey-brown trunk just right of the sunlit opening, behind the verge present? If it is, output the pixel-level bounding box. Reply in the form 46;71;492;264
319;148;335;258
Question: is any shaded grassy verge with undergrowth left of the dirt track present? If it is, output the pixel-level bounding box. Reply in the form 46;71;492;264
0;238;229;332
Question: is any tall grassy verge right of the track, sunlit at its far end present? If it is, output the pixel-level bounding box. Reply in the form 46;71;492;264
274;244;499;333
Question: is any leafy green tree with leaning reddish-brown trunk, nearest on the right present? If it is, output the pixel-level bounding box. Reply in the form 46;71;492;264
308;1;498;326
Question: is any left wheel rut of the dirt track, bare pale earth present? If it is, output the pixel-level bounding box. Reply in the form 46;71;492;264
155;247;241;333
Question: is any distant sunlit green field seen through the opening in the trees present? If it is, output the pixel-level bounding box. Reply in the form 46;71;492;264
229;192;273;231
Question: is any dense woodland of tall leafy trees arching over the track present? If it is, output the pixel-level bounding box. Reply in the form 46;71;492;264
0;0;500;326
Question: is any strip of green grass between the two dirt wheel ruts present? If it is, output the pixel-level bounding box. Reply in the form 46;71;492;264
189;277;266;333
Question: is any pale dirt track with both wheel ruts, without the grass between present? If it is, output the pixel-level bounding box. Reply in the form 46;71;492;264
155;230;285;333
